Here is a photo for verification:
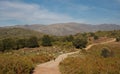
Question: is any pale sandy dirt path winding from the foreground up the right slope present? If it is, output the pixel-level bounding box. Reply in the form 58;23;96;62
33;39;115;74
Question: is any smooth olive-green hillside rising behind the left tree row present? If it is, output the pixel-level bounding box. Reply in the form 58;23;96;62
0;28;43;39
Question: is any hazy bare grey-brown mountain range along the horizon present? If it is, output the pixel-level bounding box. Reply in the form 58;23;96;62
5;23;120;36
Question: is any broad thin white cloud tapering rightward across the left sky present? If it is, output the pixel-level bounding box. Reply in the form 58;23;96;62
0;1;84;23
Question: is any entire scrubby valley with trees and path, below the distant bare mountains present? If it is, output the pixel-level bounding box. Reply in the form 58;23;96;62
0;25;120;74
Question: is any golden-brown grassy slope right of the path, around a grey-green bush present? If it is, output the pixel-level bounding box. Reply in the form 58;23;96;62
60;42;120;74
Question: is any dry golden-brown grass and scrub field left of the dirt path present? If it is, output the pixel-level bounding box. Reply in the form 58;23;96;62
0;46;77;74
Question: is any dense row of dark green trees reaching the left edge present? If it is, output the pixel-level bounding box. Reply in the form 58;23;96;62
0;37;39;52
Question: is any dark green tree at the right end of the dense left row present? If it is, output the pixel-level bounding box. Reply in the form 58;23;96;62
26;37;39;48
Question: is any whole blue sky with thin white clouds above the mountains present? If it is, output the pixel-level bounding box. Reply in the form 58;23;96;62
0;0;120;26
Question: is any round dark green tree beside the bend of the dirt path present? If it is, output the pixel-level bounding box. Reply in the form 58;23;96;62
72;38;88;49
